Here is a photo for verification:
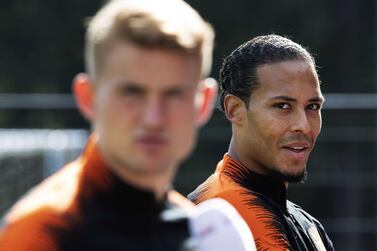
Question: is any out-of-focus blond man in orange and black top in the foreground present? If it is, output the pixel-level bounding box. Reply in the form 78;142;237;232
0;0;252;251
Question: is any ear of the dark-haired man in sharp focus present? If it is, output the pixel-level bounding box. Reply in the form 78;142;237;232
224;94;246;125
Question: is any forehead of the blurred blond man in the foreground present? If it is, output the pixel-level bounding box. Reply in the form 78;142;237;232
99;42;201;88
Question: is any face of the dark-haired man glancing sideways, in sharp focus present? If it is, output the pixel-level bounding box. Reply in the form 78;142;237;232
239;61;323;181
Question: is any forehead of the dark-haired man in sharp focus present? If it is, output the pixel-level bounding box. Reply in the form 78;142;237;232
252;60;322;99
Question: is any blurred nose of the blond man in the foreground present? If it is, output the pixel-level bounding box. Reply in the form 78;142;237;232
143;98;164;130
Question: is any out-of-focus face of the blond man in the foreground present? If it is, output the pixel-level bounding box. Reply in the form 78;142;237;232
93;43;201;176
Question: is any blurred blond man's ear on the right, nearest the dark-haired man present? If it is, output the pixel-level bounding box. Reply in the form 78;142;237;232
197;78;218;126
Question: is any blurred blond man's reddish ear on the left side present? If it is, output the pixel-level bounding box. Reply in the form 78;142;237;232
72;73;94;121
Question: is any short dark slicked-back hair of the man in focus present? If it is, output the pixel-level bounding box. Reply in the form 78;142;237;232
219;35;315;111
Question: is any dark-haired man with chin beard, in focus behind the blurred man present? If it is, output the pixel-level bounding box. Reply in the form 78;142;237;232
189;35;333;250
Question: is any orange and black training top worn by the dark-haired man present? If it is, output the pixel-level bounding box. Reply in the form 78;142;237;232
189;154;334;251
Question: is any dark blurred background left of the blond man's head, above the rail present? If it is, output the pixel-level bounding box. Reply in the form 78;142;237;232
0;0;100;93
